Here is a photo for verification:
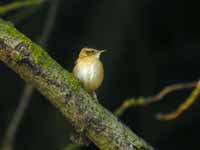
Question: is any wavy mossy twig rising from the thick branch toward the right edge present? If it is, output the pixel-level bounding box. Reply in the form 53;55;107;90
114;81;198;116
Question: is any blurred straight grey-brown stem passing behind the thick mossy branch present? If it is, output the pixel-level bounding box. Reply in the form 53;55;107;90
2;0;59;150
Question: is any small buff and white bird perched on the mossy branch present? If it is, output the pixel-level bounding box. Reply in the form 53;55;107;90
73;48;105;94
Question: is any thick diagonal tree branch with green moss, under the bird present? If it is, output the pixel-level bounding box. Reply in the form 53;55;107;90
0;20;153;150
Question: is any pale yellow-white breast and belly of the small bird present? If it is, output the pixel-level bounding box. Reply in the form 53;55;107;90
73;58;104;91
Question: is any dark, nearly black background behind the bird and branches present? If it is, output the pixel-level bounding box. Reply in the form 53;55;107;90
0;0;200;150
